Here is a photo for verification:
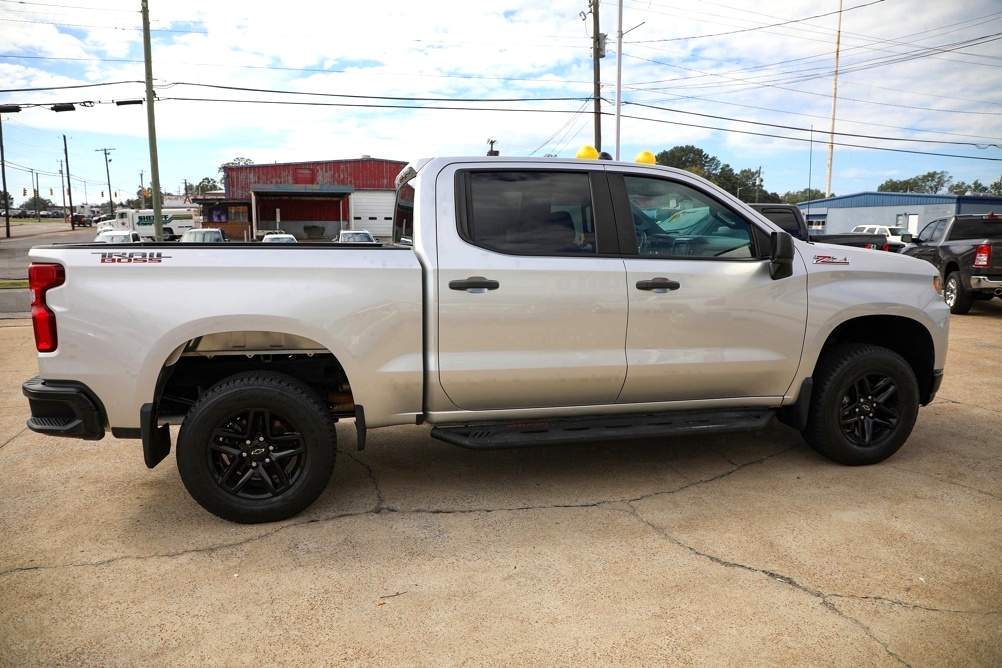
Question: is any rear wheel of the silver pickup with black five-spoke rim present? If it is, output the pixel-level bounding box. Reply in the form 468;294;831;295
177;372;337;524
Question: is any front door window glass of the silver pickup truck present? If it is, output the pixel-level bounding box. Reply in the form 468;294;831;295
624;176;755;259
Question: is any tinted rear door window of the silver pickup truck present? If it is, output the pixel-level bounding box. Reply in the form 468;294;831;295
459;169;597;255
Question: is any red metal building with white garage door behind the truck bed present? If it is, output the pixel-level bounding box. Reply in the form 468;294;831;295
195;156;407;240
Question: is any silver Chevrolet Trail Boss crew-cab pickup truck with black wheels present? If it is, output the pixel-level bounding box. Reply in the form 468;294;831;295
23;157;949;523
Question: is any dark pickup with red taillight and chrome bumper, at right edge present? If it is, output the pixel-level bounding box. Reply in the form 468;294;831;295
901;213;1002;314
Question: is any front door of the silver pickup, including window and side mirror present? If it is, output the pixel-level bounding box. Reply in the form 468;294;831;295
610;173;808;404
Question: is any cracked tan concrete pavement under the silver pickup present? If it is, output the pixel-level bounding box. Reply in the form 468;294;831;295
0;299;1002;667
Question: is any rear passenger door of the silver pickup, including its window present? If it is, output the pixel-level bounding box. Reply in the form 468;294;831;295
433;162;627;411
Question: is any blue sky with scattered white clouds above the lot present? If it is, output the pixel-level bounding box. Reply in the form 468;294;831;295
0;0;1002;204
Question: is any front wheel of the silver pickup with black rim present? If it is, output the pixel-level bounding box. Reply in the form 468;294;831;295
802;344;919;466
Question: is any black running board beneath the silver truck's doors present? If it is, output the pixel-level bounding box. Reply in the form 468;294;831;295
432;409;776;450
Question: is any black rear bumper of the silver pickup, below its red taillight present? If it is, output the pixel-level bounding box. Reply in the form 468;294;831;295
21;376;104;441
